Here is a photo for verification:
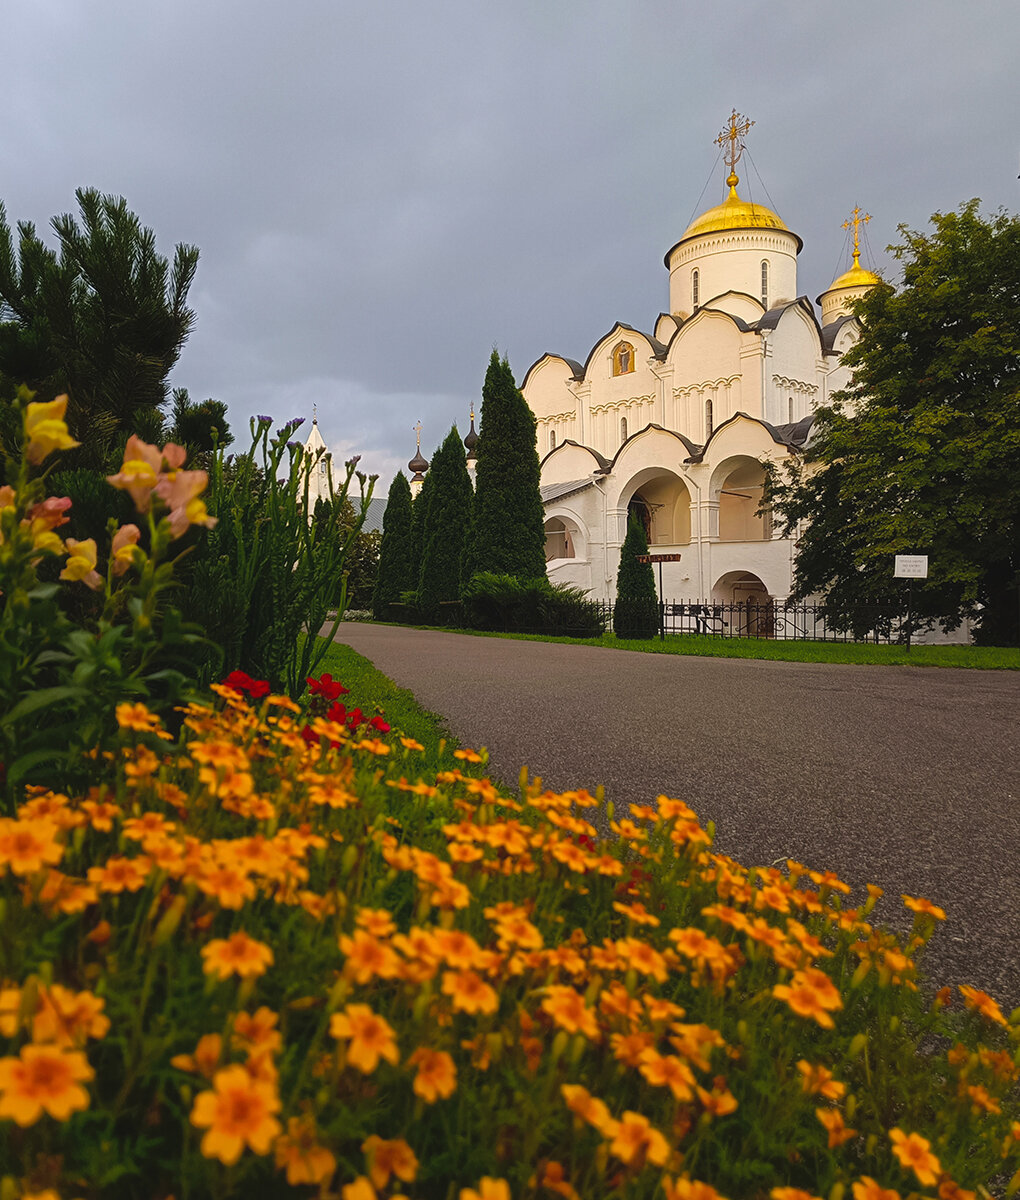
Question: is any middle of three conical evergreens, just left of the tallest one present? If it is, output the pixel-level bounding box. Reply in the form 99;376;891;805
418;425;474;620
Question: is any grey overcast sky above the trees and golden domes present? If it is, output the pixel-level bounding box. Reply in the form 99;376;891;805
0;0;1020;486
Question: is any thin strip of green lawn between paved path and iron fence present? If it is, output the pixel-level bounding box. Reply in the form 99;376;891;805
362;626;1020;671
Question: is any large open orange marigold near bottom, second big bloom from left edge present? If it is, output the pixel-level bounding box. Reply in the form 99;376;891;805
191;1066;281;1166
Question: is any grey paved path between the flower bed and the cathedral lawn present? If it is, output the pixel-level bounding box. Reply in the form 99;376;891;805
337;623;1020;1007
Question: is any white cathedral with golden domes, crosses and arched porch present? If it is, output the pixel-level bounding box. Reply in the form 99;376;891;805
521;112;878;604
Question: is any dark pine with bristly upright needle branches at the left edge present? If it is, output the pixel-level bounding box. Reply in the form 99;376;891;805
0;188;198;468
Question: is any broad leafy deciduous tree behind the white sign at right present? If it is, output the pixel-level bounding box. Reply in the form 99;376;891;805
766;200;1020;644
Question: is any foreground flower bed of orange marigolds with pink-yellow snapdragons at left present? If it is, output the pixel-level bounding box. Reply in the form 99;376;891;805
0;391;1020;1200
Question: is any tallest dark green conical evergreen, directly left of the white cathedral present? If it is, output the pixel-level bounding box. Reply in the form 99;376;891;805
466;350;546;580
